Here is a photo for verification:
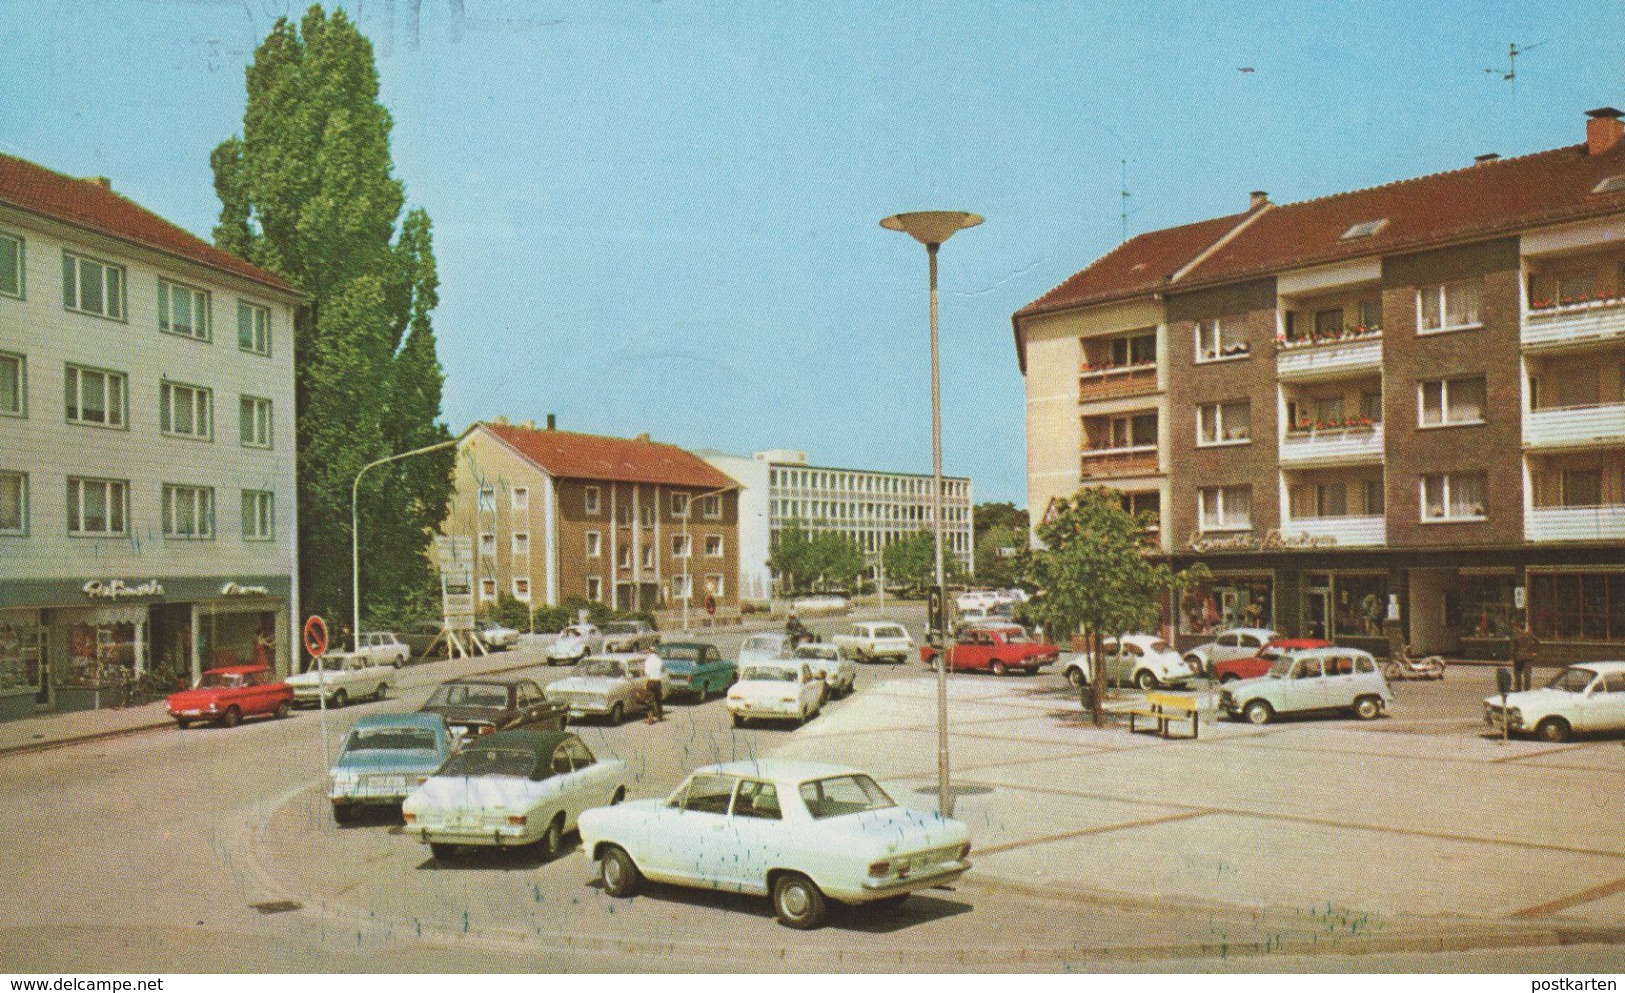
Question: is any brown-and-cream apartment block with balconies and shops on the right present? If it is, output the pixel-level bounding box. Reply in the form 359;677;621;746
1012;107;1625;661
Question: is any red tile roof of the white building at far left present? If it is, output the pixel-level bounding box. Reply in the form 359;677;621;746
0;154;297;293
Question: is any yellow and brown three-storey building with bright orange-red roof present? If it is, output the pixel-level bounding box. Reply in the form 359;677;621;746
444;414;739;611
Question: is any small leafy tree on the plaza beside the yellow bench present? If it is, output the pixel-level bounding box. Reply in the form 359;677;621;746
1025;486;1206;725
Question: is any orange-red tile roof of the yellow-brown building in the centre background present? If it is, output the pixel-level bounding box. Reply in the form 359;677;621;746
479;423;739;489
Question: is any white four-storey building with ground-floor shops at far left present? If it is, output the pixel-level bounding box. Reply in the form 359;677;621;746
0;154;301;717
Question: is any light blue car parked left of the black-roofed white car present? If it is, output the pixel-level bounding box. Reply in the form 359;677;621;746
327;713;452;824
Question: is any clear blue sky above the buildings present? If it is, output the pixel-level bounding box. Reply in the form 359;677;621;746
0;0;1625;505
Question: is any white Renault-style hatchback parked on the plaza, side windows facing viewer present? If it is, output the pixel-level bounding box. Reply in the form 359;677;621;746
1219;647;1394;725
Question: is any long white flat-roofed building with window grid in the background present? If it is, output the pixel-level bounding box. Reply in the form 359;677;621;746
699;449;975;600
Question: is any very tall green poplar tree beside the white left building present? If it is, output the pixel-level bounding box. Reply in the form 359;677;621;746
210;7;453;630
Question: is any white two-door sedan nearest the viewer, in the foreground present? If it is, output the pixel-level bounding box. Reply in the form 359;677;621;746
580;759;970;928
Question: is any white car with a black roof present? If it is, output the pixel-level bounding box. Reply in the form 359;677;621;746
401;728;627;860
